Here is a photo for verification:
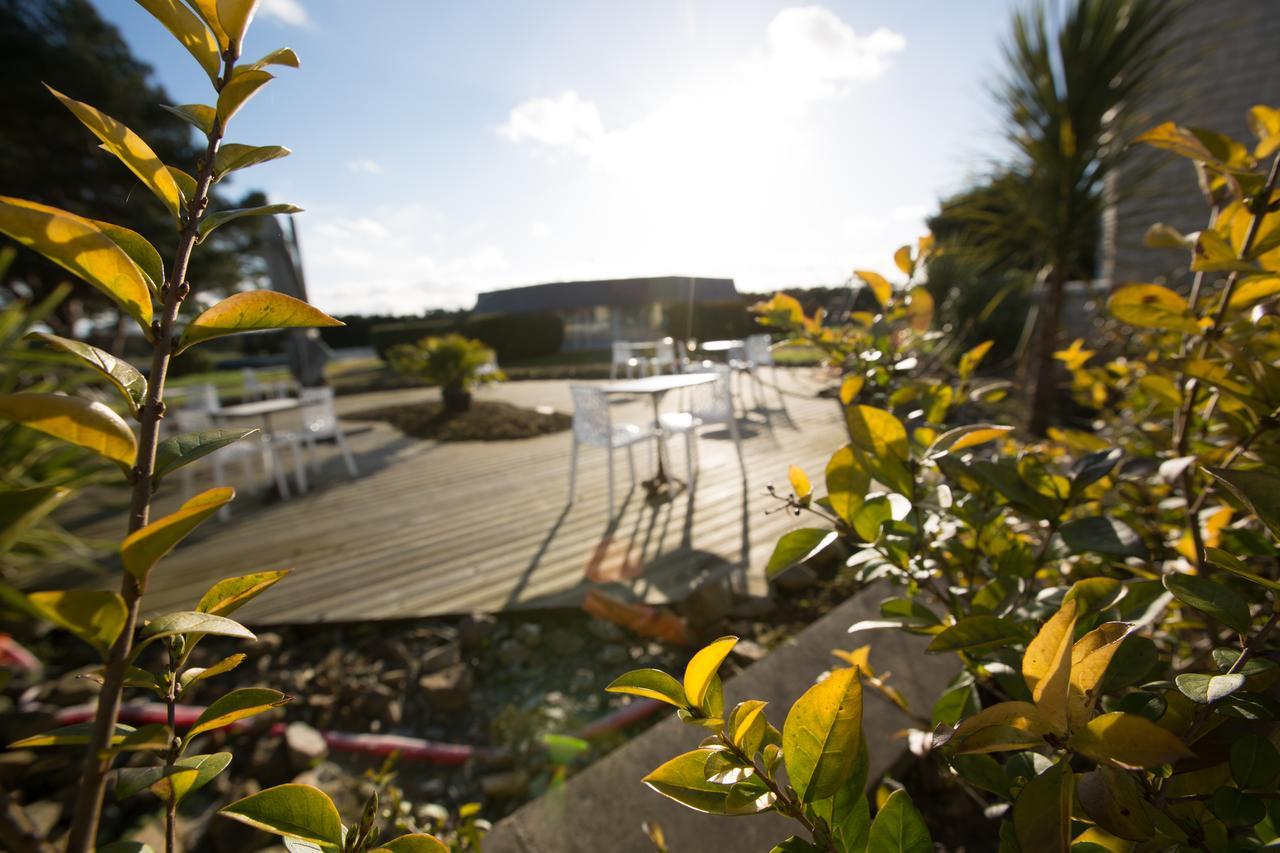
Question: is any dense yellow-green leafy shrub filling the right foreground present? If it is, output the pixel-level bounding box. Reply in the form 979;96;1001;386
611;106;1280;853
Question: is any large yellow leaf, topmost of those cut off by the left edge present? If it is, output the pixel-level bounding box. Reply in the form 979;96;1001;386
0;196;152;336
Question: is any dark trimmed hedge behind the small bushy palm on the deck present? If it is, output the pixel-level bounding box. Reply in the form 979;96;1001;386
370;314;564;364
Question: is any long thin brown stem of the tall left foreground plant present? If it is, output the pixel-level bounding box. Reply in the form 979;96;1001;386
67;51;237;853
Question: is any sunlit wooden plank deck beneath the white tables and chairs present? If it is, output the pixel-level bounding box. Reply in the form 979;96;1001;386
60;370;844;625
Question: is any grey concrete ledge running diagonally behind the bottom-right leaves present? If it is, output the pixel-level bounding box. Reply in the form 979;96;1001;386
485;587;956;853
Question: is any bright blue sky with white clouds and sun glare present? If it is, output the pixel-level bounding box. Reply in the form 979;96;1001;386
93;0;1012;314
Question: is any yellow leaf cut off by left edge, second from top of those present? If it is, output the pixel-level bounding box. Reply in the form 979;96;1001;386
0;393;138;466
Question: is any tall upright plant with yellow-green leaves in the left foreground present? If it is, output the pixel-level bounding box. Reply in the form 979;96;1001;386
0;0;445;853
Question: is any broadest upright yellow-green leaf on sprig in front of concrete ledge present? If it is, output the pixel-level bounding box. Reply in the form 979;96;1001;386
782;667;863;803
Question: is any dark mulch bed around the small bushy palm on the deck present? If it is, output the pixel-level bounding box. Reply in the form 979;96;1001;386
343;400;573;442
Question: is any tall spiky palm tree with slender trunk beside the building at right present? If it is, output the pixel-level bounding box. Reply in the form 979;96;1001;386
996;0;1179;434
